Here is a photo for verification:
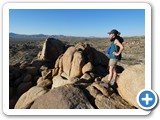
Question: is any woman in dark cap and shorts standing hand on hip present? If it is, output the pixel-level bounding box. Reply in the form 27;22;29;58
100;29;124;88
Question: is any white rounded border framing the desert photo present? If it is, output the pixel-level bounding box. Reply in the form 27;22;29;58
3;3;151;115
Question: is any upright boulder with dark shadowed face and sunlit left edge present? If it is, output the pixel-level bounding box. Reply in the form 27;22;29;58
39;38;65;64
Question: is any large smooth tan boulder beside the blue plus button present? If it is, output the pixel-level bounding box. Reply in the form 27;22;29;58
117;65;145;108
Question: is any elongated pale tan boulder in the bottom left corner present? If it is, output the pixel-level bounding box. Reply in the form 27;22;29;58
15;86;47;109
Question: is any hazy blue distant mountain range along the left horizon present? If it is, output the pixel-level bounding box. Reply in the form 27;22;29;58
9;33;96;40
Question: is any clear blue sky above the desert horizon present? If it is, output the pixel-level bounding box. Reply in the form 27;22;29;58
9;9;145;37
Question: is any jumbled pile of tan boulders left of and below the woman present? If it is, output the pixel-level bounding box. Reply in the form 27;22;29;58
9;38;145;109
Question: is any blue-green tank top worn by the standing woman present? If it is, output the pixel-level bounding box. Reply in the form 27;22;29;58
109;39;120;59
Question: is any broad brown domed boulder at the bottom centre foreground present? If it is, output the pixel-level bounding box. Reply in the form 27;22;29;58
31;85;93;109
